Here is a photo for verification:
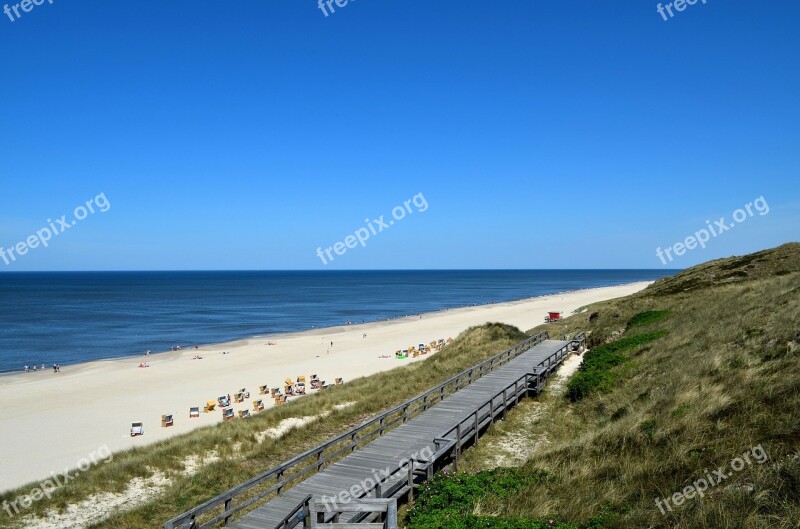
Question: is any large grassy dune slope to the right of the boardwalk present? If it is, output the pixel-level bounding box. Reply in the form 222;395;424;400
432;244;800;529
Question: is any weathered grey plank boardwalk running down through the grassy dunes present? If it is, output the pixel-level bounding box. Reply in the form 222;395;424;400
228;340;572;529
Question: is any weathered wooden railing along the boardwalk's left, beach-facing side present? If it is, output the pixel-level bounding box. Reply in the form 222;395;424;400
164;331;548;529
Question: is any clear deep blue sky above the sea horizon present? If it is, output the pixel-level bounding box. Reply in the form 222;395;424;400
0;0;800;272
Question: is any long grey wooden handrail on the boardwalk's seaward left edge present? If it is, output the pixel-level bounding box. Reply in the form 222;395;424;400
164;331;549;529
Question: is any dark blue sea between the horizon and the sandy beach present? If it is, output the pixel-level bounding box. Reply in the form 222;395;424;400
0;270;671;372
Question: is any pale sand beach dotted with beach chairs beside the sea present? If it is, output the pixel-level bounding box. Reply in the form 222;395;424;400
0;282;649;491
